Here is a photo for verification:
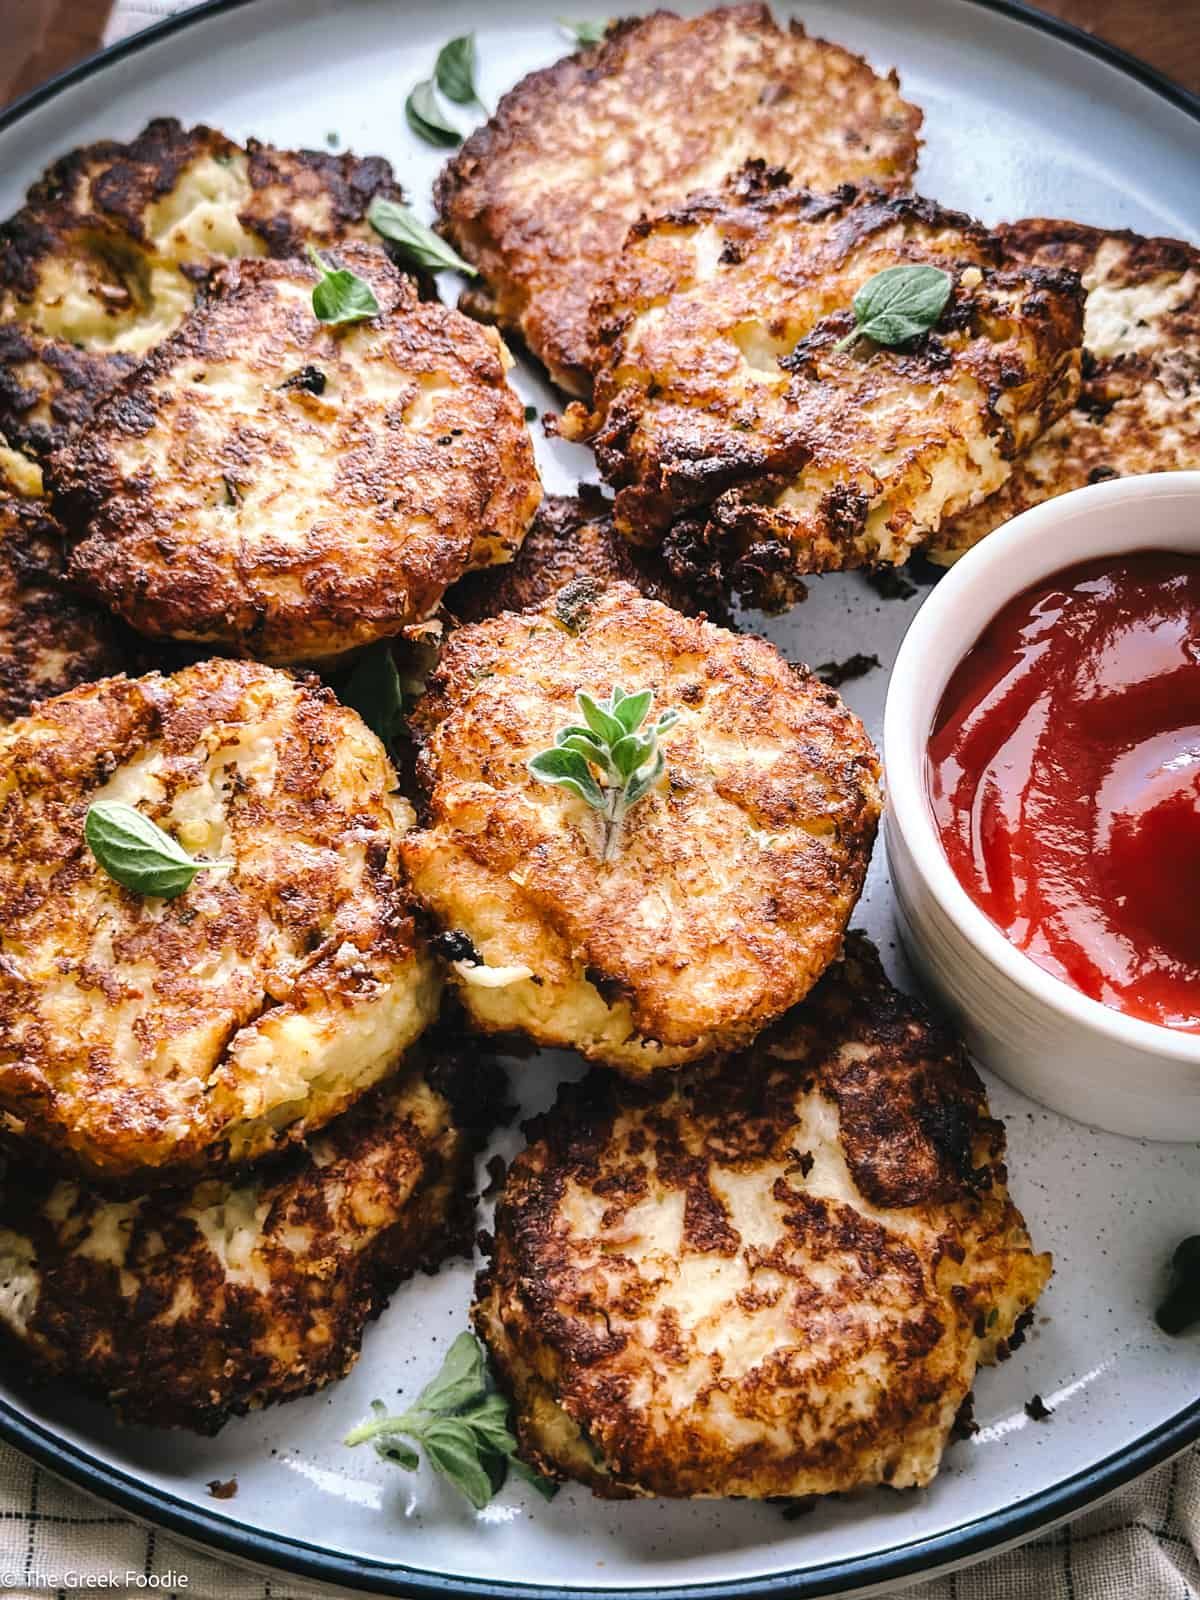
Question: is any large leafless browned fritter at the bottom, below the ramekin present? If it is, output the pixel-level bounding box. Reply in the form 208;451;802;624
475;934;1050;1498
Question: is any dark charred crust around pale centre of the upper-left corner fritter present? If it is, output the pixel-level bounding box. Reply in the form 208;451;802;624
0;117;403;454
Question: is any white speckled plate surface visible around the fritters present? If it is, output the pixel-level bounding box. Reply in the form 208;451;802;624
0;0;1200;1600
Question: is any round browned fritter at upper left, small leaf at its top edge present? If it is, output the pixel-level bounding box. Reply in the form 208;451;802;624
48;245;541;662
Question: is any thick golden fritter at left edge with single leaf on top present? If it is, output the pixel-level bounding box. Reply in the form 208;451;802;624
0;661;438;1179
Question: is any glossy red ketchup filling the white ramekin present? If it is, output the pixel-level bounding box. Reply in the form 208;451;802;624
928;550;1200;1032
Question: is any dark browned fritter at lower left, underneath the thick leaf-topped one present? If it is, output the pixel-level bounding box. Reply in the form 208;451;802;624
0;1070;474;1434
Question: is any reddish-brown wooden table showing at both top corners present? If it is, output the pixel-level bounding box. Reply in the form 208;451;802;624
0;0;1200;104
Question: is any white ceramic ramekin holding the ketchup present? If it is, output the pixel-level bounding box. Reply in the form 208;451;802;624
883;472;1200;1141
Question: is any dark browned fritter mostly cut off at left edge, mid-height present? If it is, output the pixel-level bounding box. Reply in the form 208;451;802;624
0;490;141;722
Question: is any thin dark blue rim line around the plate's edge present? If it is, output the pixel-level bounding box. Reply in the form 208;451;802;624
0;0;1200;1600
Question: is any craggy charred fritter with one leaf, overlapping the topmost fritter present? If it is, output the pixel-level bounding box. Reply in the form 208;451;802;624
563;162;1083;606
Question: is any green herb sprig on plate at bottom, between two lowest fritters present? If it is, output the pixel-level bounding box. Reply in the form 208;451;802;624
344;1333;558;1510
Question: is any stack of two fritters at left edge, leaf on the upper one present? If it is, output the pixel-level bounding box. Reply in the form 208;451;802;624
0;661;470;1427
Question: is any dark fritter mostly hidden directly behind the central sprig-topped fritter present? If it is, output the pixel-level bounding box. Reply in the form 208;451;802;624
445;483;712;622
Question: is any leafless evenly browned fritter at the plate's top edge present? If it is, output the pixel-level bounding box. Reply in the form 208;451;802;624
435;5;922;394
